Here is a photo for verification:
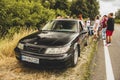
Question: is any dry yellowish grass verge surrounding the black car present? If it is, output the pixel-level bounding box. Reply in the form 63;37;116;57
0;29;96;80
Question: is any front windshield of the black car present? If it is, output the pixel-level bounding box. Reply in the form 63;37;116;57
42;20;77;32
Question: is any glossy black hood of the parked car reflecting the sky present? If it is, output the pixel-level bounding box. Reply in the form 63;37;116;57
23;31;79;46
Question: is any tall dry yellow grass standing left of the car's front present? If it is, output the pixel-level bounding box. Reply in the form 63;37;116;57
0;28;34;59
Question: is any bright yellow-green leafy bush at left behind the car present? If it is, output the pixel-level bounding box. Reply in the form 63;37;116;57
0;0;65;36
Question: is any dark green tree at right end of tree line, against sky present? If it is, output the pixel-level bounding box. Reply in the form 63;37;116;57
70;0;99;19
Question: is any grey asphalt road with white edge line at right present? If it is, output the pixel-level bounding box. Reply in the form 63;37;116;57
90;24;120;80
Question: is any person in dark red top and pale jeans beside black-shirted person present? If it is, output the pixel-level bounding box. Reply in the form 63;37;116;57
101;15;107;40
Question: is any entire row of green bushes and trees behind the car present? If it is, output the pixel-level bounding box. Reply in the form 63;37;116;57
0;0;99;36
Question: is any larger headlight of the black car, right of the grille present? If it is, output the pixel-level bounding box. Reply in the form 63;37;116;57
45;46;70;54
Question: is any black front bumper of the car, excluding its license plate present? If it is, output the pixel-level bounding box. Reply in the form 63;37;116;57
15;48;73;67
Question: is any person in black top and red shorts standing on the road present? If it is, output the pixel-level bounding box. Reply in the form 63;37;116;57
106;13;114;46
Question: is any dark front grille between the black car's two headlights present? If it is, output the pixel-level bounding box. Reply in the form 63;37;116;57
24;46;45;53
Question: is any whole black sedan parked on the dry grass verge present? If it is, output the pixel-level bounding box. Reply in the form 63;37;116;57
15;19;88;66
